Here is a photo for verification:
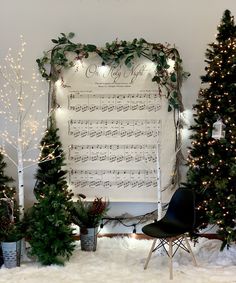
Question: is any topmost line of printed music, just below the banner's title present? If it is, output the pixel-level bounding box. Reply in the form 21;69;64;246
68;91;161;112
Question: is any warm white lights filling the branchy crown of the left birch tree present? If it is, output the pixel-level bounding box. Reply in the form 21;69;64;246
0;36;47;166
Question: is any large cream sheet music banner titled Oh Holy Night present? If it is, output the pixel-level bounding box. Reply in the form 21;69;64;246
55;55;175;202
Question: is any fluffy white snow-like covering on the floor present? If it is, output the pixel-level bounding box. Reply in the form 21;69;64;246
0;238;236;283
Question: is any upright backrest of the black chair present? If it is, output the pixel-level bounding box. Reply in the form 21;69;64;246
162;188;195;231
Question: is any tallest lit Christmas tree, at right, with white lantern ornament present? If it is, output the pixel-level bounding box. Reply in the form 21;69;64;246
185;10;236;249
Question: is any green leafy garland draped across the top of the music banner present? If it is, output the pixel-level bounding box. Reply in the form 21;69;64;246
36;32;189;111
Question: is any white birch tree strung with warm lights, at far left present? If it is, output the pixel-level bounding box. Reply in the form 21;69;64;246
0;37;50;218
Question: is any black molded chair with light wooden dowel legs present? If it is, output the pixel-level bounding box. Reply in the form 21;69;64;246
142;188;197;279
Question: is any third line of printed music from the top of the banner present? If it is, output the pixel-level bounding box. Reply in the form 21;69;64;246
68;144;157;163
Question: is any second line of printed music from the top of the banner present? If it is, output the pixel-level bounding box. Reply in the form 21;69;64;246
68;119;160;138
